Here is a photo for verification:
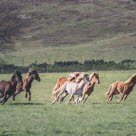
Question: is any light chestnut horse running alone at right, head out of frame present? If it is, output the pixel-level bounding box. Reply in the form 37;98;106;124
106;73;136;102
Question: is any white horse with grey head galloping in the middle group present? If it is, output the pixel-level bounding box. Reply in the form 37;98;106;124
52;74;90;104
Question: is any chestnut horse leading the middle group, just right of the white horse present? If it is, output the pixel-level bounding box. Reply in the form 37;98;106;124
80;73;100;103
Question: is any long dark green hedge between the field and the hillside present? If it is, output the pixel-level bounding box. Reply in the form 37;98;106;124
0;59;136;73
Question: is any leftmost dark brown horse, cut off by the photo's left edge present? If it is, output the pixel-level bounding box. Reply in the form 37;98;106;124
0;71;22;104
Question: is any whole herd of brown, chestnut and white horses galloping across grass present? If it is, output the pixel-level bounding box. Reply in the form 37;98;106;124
0;69;136;104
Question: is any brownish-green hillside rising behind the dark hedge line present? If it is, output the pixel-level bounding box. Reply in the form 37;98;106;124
0;0;136;65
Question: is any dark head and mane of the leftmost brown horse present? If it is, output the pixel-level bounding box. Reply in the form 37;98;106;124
11;71;23;85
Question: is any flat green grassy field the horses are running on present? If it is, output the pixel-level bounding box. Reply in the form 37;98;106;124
0;71;136;136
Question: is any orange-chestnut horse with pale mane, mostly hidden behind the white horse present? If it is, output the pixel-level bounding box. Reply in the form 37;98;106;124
52;72;80;99
